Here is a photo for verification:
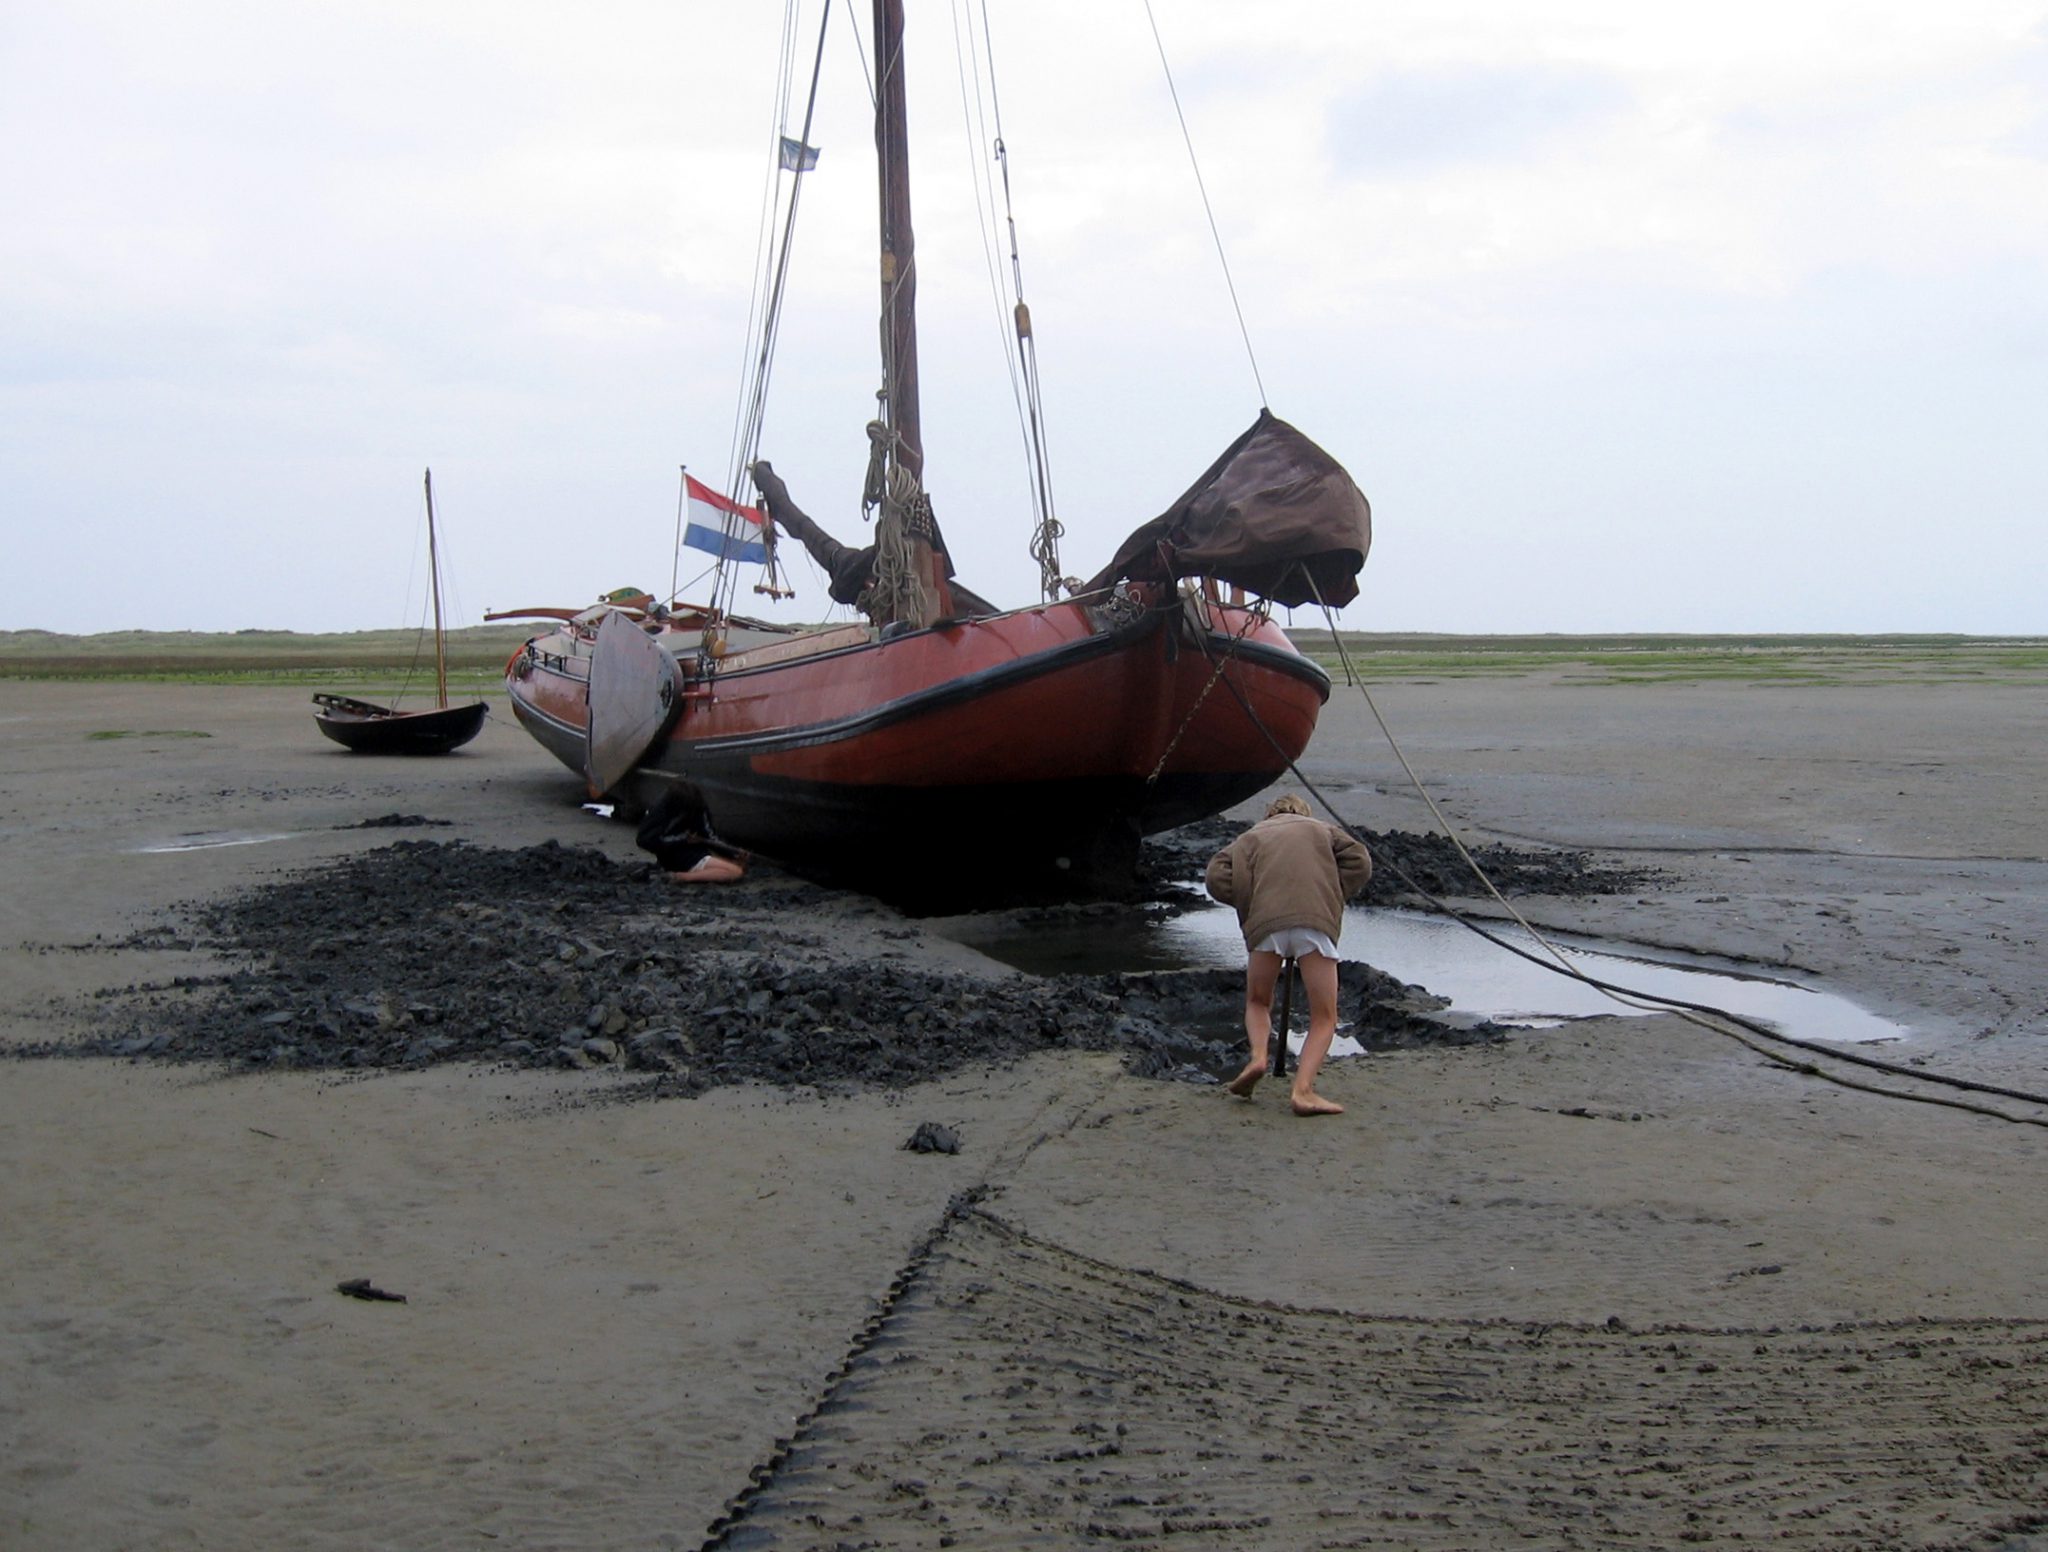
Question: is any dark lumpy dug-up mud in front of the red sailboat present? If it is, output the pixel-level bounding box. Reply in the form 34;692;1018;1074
48;829;1646;1093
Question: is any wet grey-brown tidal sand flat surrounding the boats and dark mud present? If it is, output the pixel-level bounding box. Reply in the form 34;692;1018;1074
0;680;2048;1552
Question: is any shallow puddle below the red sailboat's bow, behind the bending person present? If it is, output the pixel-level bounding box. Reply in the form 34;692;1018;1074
928;892;1909;1044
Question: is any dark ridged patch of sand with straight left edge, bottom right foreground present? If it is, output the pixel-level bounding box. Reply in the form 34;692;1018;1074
723;1212;2048;1548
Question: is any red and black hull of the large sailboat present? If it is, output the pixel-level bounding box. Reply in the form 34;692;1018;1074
508;602;1329;895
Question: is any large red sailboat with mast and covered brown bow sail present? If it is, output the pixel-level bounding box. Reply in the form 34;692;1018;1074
506;0;1370;899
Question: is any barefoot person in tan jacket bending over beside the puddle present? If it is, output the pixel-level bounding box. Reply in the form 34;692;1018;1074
1204;792;1372;1116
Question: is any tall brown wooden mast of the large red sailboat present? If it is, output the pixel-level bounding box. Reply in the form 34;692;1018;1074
874;0;952;624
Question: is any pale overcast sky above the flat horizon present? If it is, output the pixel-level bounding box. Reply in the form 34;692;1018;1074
0;0;2048;635
